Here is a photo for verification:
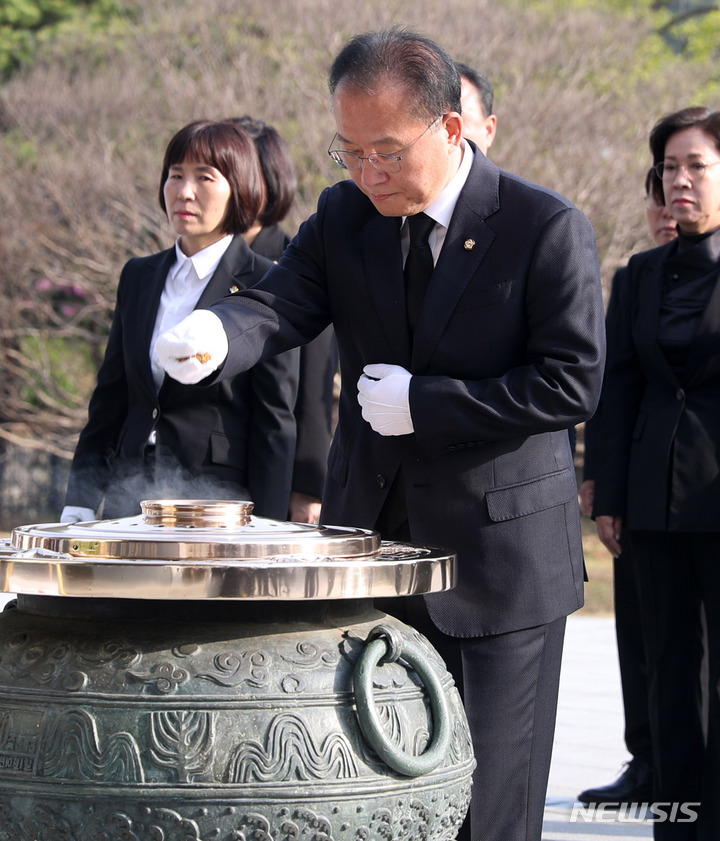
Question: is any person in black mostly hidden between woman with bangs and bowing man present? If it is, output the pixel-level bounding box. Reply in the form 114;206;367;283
232;115;338;523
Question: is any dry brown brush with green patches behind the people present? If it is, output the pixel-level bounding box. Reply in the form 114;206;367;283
0;0;720;457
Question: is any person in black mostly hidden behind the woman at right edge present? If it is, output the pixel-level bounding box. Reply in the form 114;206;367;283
578;168;677;804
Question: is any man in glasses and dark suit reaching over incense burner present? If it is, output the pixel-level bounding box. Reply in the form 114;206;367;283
157;29;604;841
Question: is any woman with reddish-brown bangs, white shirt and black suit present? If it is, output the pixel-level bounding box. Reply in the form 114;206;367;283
61;121;299;522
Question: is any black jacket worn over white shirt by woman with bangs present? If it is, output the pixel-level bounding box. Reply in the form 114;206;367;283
66;231;299;519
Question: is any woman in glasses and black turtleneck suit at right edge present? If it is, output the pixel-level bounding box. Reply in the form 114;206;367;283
593;108;720;841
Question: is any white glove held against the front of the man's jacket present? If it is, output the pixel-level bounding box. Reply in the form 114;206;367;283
358;364;414;435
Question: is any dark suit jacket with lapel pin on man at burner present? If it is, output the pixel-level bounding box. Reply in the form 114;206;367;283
207;148;604;636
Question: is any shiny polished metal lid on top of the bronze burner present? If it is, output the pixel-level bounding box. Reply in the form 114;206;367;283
0;500;455;600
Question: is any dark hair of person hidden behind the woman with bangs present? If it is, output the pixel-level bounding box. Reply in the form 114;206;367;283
228;114;297;227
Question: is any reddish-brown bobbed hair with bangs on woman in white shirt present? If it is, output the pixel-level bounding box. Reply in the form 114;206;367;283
159;120;265;234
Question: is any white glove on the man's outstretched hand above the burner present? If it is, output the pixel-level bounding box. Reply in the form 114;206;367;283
154;310;228;385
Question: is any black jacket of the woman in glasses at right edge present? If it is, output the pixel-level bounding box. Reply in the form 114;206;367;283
593;232;720;532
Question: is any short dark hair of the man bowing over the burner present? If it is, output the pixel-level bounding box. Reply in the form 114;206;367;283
328;26;460;120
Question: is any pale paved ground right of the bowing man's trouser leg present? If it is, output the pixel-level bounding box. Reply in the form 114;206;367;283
542;616;652;841
